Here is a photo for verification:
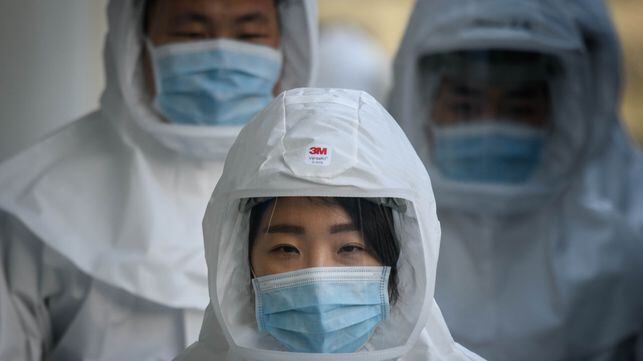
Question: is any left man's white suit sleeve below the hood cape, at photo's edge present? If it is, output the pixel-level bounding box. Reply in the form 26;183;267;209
0;212;88;361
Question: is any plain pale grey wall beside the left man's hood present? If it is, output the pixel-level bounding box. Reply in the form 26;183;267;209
0;0;107;160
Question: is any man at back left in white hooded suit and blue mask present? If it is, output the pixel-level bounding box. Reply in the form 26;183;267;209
0;0;317;361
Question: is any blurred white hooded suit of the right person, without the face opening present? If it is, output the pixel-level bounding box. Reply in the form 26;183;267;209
391;0;643;360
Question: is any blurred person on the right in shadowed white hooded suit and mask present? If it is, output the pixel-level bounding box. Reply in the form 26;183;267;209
390;0;643;360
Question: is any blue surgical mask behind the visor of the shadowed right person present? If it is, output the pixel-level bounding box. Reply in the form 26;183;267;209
432;121;545;183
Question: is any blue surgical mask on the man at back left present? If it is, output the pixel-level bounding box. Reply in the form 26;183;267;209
147;39;282;125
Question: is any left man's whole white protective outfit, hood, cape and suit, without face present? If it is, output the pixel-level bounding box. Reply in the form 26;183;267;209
0;0;317;360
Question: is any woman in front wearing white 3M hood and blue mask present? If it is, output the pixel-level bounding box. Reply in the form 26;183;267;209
175;88;480;361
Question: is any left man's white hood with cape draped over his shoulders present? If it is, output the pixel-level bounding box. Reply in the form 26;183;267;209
0;0;317;309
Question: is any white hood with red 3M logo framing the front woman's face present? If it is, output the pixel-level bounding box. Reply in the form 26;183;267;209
177;88;479;361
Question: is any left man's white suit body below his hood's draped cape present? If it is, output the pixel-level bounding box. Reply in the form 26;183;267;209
0;210;191;361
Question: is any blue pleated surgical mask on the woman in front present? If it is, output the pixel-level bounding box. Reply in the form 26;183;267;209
252;267;390;353
